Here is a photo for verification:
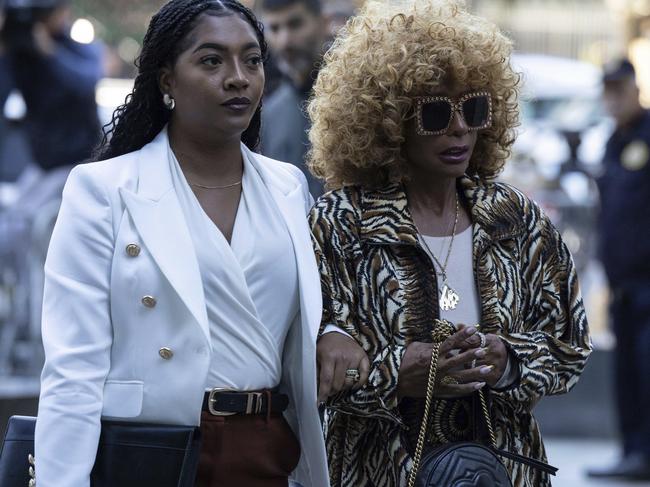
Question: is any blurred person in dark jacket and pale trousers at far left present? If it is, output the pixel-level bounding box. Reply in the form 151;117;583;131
0;0;103;350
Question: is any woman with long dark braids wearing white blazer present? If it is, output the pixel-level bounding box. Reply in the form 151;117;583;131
35;0;368;487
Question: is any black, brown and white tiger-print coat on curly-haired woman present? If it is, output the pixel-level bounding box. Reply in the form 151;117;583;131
310;177;591;487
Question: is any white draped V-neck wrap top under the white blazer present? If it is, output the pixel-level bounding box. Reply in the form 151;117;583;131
169;144;299;391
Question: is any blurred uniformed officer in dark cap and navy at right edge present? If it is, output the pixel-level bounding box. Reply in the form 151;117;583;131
589;59;650;480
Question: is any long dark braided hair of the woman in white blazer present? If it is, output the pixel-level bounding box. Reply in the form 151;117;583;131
94;0;268;160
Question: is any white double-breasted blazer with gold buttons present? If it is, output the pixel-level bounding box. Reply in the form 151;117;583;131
35;130;329;487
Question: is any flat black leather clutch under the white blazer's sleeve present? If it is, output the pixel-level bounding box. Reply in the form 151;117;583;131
0;416;201;487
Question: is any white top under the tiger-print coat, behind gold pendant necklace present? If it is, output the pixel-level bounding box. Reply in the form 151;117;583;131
418;226;518;389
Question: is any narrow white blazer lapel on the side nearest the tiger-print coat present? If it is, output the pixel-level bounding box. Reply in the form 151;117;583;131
242;144;323;342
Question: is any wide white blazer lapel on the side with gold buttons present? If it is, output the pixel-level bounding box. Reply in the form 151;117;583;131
120;130;212;348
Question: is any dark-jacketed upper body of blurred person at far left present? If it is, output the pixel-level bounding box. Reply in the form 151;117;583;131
0;0;102;170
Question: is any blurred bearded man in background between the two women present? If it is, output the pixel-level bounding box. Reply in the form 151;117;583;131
261;0;328;197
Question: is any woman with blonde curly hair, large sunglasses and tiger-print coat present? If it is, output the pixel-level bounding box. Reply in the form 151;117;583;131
309;0;591;487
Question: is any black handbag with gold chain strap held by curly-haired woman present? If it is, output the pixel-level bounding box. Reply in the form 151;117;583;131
408;320;557;487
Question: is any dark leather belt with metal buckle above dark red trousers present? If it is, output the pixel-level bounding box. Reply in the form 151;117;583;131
202;388;289;416
